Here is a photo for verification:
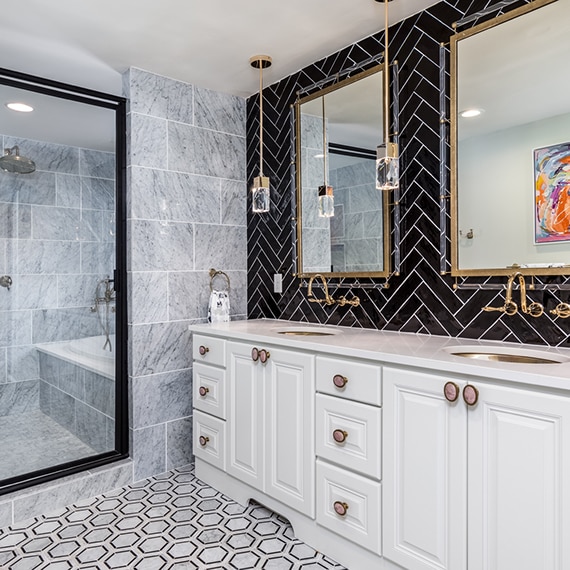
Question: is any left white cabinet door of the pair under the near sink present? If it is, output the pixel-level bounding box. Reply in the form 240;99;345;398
382;368;467;570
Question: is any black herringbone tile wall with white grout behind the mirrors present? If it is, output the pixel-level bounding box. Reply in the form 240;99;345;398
247;0;570;346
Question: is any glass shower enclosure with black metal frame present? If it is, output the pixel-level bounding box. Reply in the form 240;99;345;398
0;70;128;493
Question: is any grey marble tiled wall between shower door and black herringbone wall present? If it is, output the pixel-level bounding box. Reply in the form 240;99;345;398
124;68;247;480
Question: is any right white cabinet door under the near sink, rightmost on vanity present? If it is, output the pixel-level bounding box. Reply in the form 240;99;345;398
468;385;570;570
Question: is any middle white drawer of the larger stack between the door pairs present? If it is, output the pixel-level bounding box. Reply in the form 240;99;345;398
316;394;382;479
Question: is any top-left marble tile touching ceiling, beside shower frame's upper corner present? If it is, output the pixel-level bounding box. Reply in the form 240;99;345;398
124;67;194;124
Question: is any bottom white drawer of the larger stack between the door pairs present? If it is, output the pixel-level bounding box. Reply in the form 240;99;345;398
317;460;382;554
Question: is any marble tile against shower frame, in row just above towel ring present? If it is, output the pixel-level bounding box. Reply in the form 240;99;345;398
130;220;194;271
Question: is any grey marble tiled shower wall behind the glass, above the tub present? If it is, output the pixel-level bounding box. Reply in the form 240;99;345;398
0;135;115;415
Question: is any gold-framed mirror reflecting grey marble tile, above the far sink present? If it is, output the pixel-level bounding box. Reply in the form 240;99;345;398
295;65;390;278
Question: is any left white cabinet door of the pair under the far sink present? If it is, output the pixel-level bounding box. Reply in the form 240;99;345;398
227;343;264;489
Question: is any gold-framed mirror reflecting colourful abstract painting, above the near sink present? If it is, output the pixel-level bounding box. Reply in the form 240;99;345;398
450;0;570;276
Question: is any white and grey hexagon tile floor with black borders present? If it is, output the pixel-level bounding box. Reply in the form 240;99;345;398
0;466;342;570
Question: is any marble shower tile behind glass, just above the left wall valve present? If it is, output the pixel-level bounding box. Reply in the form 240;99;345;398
6;240;81;275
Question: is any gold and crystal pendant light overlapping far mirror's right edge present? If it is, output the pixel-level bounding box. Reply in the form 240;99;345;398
376;0;400;191
